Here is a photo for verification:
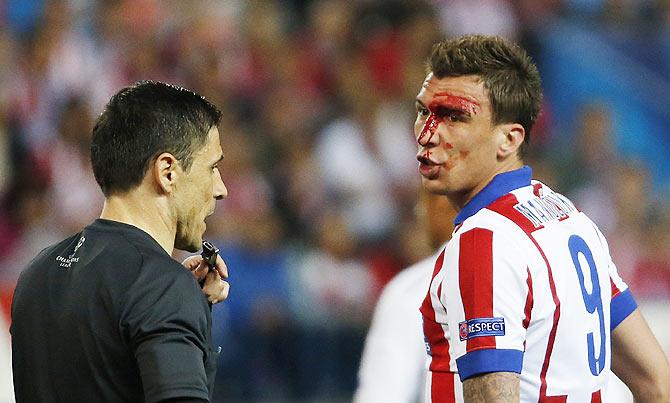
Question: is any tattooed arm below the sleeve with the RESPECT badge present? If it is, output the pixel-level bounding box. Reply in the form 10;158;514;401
463;372;520;403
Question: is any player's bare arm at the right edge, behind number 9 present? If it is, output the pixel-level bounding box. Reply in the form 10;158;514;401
612;309;670;403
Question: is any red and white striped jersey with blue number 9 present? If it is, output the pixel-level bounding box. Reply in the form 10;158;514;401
421;167;636;403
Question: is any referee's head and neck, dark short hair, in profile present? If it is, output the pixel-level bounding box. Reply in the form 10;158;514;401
91;81;228;253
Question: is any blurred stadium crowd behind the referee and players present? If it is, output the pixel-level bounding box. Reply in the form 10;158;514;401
0;0;670;402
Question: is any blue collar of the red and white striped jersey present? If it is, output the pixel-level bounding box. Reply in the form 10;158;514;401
454;165;533;225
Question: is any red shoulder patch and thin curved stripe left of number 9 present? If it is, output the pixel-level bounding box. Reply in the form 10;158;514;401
488;193;565;402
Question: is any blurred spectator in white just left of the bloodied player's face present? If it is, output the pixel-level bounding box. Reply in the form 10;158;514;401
314;49;418;241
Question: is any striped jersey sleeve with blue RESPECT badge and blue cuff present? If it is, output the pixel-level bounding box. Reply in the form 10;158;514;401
451;228;532;381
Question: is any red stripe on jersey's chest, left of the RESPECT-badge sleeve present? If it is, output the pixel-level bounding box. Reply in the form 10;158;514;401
419;250;451;371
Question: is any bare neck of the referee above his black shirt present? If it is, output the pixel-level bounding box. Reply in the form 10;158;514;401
100;189;177;255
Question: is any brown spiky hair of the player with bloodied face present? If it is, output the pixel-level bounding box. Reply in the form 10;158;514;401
426;35;542;157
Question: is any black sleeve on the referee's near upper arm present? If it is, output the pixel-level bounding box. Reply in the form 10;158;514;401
121;260;211;402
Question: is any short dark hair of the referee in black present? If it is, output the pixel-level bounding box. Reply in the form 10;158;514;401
91;81;221;196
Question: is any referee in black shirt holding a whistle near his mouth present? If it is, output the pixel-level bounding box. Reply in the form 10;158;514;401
11;81;229;403
